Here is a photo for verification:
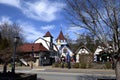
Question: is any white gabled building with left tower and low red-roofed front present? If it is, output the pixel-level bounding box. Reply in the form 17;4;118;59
19;31;58;66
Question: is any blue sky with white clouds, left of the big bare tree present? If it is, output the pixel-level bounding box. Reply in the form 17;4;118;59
0;0;81;42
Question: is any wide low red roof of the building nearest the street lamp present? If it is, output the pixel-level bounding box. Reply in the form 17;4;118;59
18;43;48;52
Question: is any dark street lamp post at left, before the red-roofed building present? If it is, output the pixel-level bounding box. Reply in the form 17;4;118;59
12;37;20;73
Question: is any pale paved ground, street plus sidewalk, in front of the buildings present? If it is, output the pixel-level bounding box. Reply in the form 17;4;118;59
1;67;115;80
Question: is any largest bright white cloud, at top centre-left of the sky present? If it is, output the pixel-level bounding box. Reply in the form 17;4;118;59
23;0;64;22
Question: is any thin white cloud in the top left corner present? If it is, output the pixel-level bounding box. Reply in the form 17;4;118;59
0;0;20;8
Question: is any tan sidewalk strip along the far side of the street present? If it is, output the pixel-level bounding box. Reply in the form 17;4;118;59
0;66;115;76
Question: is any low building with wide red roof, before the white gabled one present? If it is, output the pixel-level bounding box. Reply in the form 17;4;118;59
18;43;50;66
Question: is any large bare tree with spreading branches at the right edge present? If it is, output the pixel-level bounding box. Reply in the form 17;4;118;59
65;0;120;80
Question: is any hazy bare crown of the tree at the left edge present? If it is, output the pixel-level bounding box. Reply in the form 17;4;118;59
0;22;24;46
